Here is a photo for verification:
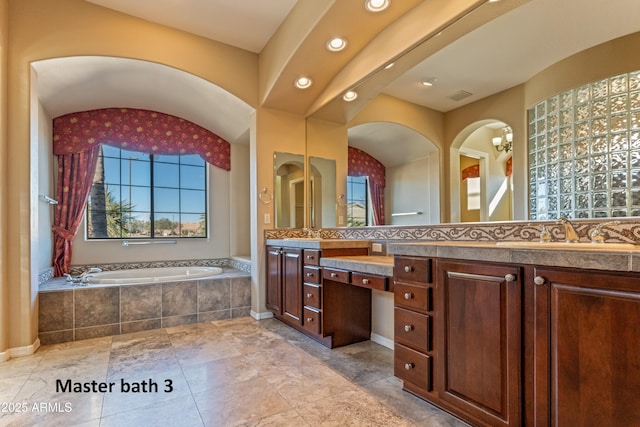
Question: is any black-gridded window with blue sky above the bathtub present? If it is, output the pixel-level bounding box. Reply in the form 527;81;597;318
86;145;207;239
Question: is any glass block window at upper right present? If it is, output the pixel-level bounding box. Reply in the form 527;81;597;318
528;71;640;220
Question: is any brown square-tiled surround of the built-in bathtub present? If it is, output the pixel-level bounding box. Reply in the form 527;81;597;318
38;267;251;344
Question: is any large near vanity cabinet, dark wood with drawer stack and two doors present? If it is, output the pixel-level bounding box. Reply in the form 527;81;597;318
394;255;640;427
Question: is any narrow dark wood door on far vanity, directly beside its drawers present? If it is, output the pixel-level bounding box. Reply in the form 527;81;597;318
282;248;303;324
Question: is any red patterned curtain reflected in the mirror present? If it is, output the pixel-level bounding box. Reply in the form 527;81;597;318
348;147;386;225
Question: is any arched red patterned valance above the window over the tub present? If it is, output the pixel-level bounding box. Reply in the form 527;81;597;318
53;108;231;170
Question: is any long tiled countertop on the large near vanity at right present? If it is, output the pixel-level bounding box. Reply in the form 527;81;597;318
387;241;640;271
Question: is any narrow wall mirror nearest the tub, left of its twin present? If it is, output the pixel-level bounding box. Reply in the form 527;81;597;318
273;152;305;228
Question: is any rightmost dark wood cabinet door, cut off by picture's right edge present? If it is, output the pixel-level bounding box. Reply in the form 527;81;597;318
530;268;640;426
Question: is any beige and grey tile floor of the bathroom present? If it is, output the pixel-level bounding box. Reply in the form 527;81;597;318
0;317;465;427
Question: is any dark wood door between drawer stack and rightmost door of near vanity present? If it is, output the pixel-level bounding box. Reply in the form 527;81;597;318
435;260;522;426
